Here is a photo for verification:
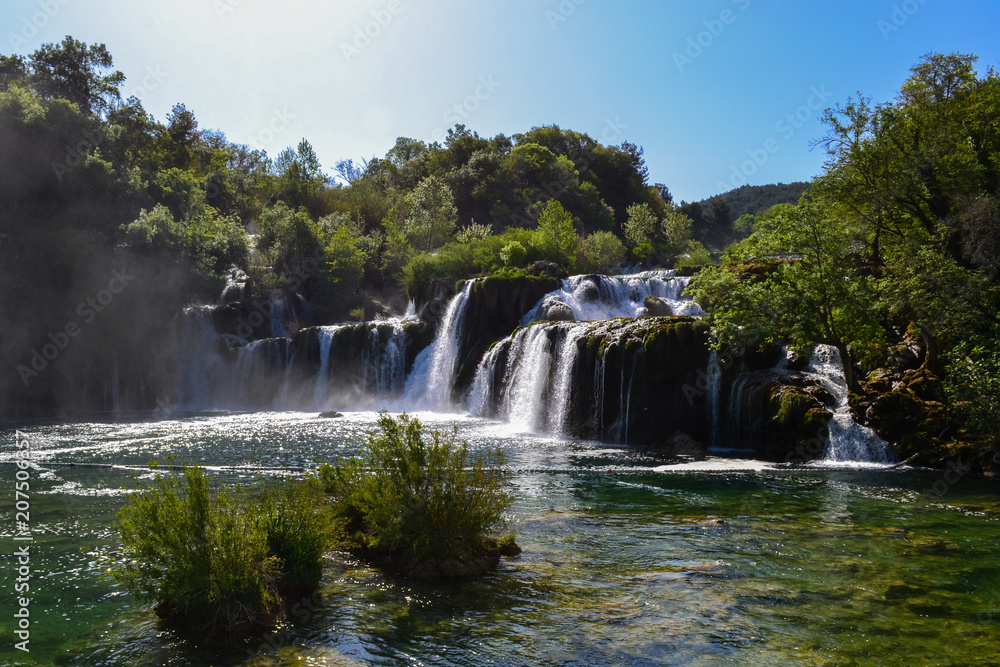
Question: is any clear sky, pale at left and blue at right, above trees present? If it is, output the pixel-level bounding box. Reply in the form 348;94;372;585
0;0;1000;201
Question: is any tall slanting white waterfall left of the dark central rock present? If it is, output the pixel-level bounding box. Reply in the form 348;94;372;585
404;280;473;411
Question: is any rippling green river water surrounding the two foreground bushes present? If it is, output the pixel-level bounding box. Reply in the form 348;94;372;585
0;413;1000;665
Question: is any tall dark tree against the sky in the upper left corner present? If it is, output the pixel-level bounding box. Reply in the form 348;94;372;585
31;36;125;114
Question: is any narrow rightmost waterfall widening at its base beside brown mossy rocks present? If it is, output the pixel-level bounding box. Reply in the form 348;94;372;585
808;345;893;464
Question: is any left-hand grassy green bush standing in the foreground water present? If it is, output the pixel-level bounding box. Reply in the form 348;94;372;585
111;466;328;636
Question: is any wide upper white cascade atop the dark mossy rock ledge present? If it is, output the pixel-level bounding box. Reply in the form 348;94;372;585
524;271;704;324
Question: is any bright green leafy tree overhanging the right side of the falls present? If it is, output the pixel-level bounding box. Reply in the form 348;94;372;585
689;197;884;391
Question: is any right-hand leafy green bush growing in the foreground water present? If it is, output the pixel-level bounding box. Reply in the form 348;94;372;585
320;412;513;575
